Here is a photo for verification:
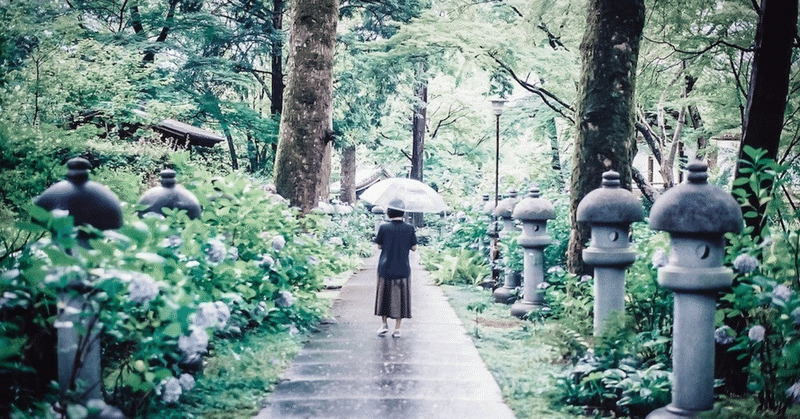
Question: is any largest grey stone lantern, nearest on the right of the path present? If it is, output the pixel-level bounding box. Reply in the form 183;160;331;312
647;160;742;419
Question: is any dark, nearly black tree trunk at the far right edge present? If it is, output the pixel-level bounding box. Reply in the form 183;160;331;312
736;0;797;237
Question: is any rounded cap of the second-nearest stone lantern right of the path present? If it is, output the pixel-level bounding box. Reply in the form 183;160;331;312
575;170;644;224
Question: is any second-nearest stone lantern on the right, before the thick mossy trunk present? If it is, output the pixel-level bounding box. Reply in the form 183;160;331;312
575;170;644;335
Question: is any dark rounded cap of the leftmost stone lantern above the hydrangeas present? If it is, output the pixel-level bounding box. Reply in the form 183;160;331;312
33;157;122;230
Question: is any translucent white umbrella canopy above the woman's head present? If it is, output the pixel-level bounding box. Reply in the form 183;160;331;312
361;178;447;212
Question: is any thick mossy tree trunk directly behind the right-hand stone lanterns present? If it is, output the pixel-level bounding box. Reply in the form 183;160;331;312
567;0;644;273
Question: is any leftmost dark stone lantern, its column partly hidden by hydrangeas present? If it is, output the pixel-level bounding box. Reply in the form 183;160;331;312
33;158;122;402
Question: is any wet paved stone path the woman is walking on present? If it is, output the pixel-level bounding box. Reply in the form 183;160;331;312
256;252;514;419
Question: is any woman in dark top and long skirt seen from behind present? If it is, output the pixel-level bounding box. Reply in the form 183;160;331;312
375;208;417;338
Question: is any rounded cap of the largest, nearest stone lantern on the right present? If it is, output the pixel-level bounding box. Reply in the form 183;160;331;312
650;160;742;234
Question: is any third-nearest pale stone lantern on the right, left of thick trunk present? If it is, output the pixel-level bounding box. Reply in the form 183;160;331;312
511;187;556;318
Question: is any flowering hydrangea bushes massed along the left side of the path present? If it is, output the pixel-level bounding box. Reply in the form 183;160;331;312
0;160;376;417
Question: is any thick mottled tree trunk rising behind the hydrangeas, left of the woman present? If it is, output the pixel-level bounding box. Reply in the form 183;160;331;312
275;0;339;213
